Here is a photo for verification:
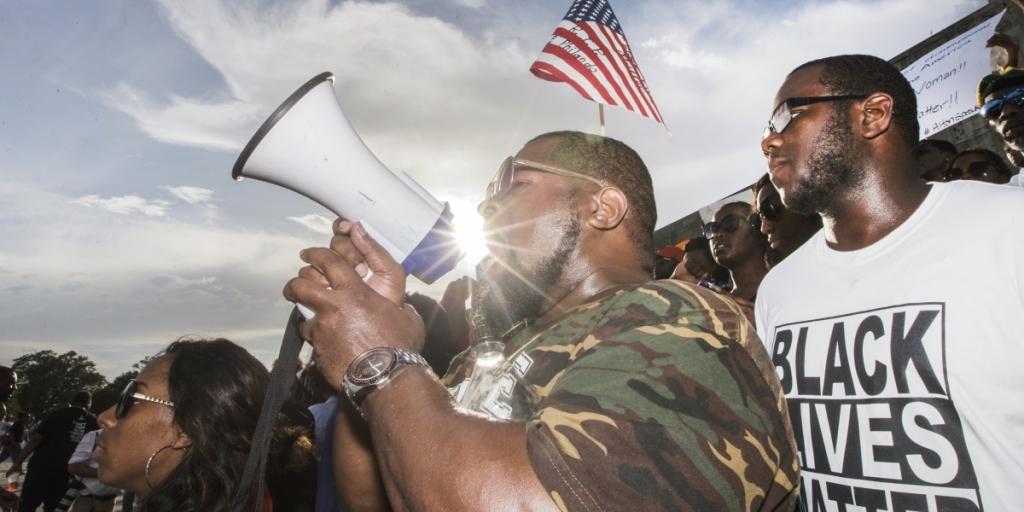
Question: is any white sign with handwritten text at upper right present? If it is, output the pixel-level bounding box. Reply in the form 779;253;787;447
903;11;1006;138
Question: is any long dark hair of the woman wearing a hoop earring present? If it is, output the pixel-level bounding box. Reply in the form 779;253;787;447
139;338;270;512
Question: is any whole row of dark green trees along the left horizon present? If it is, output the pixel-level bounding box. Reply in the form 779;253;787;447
7;350;150;419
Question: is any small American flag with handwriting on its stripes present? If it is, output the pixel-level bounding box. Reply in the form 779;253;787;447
529;0;668;128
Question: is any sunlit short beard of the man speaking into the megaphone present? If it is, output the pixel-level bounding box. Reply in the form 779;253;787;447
477;200;583;335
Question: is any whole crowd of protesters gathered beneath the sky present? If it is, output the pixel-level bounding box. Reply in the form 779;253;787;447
0;29;1024;512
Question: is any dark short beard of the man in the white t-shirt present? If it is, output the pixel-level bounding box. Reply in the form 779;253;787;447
785;103;864;215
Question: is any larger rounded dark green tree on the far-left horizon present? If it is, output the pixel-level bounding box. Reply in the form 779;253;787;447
10;350;106;418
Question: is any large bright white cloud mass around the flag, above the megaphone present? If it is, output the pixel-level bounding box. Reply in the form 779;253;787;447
94;0;981;228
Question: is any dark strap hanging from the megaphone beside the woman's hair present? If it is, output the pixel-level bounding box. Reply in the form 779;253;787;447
231;307;305;512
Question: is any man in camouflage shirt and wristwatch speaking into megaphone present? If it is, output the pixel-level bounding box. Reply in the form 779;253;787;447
285;132;799;511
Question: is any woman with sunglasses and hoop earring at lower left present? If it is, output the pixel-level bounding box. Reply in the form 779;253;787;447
92;339;270;512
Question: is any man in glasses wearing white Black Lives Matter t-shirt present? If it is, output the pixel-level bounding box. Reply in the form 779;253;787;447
757;55;1024;512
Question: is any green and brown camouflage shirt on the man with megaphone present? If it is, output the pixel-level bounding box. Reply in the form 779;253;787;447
444;281;800;511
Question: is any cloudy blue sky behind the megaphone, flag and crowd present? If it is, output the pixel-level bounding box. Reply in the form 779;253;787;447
0;0;985;377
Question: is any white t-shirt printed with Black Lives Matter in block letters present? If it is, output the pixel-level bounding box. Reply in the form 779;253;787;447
756;181;1024;512
